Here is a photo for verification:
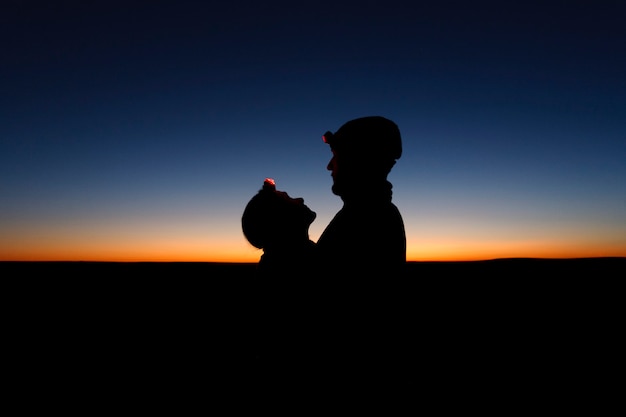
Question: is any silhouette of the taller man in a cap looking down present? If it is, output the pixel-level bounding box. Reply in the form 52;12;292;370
317;116;406;277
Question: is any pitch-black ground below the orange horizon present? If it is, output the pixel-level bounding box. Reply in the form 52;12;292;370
0;258;626;406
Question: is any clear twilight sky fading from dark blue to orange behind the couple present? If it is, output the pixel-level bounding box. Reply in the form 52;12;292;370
0;0;626;261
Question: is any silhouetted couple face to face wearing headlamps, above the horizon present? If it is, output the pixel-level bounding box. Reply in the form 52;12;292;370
241;116;406;279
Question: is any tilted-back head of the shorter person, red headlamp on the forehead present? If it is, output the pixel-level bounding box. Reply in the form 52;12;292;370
241;178;316;249
